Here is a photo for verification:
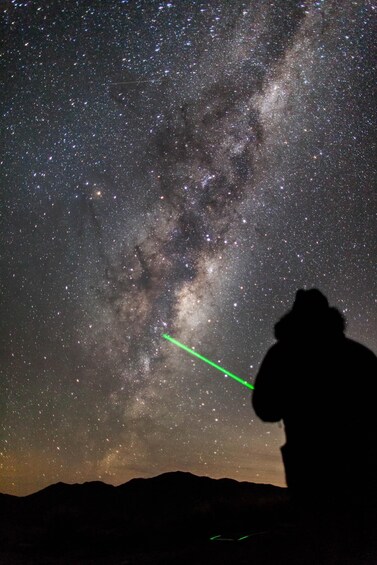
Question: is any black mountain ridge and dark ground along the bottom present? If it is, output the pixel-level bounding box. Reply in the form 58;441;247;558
0;472;377;565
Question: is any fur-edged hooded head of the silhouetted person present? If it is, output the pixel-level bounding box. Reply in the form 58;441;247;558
275;288;345;341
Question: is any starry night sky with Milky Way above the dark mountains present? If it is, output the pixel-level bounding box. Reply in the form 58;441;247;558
0;0;377;495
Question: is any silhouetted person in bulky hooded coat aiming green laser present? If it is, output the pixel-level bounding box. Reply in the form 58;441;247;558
252;289;377;508
